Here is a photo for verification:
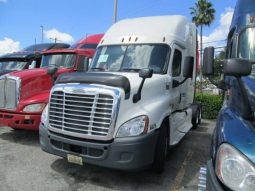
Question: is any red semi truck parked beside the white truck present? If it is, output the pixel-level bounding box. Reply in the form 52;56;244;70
0;34;103;130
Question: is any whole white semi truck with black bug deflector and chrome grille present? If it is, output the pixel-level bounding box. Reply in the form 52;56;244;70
39;15;201;172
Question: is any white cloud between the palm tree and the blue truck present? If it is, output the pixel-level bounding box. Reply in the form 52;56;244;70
198;8;234;50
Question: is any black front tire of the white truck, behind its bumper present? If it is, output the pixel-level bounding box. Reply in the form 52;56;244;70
152;123;168;173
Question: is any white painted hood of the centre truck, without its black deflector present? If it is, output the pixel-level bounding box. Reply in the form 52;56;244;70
111;73;171;133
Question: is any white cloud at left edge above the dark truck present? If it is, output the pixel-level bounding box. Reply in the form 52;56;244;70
0;37;20;55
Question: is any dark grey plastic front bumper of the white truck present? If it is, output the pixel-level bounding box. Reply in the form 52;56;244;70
39;123;158;171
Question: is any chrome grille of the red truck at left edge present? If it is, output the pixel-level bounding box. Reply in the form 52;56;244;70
0;75;20;110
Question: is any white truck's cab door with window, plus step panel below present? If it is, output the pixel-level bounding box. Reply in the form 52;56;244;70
169;44;190;145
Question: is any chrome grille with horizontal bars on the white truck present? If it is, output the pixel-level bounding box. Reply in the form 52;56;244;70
49;87;114;137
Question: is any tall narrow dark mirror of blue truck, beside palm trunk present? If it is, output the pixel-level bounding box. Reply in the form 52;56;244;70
202;47;214;76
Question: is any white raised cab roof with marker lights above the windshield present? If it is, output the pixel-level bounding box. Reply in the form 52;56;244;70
100;15;195;45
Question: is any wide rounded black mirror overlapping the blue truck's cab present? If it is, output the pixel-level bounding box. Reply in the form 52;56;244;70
223;58;252;77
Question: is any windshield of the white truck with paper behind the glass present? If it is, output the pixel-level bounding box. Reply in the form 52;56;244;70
91;44;170;73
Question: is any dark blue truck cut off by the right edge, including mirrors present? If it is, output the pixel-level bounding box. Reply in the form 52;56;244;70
199;0;255;191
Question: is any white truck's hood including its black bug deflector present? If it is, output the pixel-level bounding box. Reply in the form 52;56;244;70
56;72;176;136
